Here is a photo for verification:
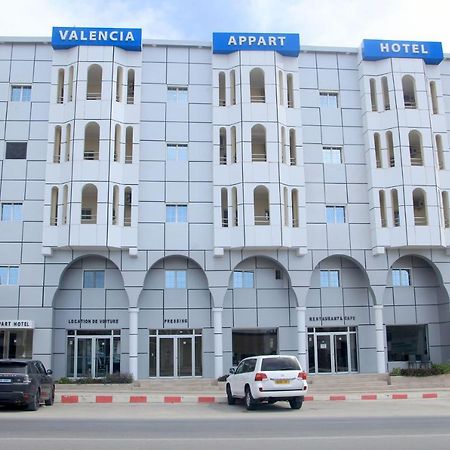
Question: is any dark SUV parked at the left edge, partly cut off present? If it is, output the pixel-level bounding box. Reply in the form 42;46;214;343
0;359;55;411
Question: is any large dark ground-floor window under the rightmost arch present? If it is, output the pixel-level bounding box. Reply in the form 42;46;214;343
386;325;430;365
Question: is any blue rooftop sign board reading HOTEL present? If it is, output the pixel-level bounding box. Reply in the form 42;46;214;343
362;39;444;64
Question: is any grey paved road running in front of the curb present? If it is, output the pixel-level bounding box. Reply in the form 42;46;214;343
0;400;450;450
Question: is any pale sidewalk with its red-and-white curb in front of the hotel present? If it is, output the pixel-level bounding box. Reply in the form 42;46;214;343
55;375;450;404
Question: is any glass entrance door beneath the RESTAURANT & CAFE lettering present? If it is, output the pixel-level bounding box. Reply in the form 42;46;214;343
308;327;358;373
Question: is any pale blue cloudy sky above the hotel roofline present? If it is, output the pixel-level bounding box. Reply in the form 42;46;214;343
0;0;450;53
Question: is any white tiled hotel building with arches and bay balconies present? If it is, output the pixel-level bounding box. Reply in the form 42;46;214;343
0;29;450;378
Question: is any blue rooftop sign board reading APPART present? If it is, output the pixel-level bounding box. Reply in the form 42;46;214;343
213;33;300;56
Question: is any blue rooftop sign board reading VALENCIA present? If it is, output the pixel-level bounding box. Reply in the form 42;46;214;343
52;27;142;52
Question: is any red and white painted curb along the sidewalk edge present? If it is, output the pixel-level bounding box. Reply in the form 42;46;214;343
55;392;444;404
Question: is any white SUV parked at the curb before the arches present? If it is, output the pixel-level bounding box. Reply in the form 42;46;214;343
226;355;308;410
